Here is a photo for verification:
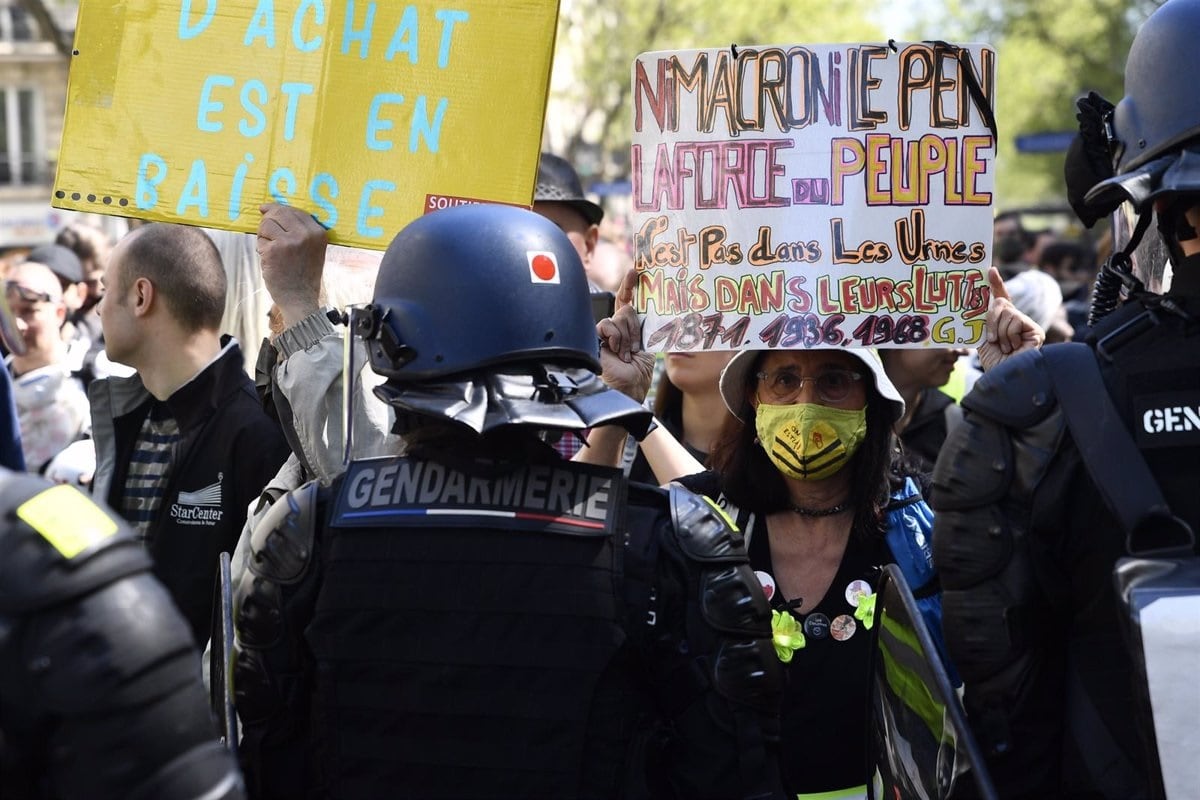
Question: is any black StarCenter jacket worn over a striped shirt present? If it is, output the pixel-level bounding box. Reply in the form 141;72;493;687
89;337;289;646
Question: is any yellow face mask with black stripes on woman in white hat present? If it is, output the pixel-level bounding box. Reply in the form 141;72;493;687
755;403;866;481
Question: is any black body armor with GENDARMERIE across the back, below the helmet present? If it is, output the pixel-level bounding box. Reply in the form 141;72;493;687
235;457;779;798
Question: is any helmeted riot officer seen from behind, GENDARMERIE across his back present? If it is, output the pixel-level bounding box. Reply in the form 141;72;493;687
235;206;779;799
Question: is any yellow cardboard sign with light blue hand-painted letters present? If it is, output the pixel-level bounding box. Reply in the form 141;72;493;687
52;0;558;249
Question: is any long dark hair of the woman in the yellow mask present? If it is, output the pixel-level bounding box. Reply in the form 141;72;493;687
709;356;896;536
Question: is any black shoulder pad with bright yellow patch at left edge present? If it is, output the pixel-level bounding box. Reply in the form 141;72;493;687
0;470;150;614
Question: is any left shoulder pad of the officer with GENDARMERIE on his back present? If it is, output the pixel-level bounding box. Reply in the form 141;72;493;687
250;481;320;584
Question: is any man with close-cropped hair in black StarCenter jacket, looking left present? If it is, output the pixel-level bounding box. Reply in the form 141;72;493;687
89;223;288;646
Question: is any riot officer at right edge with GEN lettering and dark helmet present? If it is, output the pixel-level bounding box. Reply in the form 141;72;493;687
932;0;1200;800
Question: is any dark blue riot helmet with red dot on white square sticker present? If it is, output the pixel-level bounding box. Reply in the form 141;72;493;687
359;204;600;385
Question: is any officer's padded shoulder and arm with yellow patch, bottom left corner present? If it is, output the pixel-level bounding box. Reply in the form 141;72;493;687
0;470;244;800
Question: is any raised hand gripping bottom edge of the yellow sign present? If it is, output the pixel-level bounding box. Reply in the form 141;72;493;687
256;203;329;326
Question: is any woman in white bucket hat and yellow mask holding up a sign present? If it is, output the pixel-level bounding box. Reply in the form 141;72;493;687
580;269;1044;798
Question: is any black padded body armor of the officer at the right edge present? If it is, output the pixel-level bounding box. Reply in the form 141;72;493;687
934;297;1200;800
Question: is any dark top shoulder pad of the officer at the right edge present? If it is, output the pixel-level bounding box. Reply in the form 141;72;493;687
962;350;1057;428
